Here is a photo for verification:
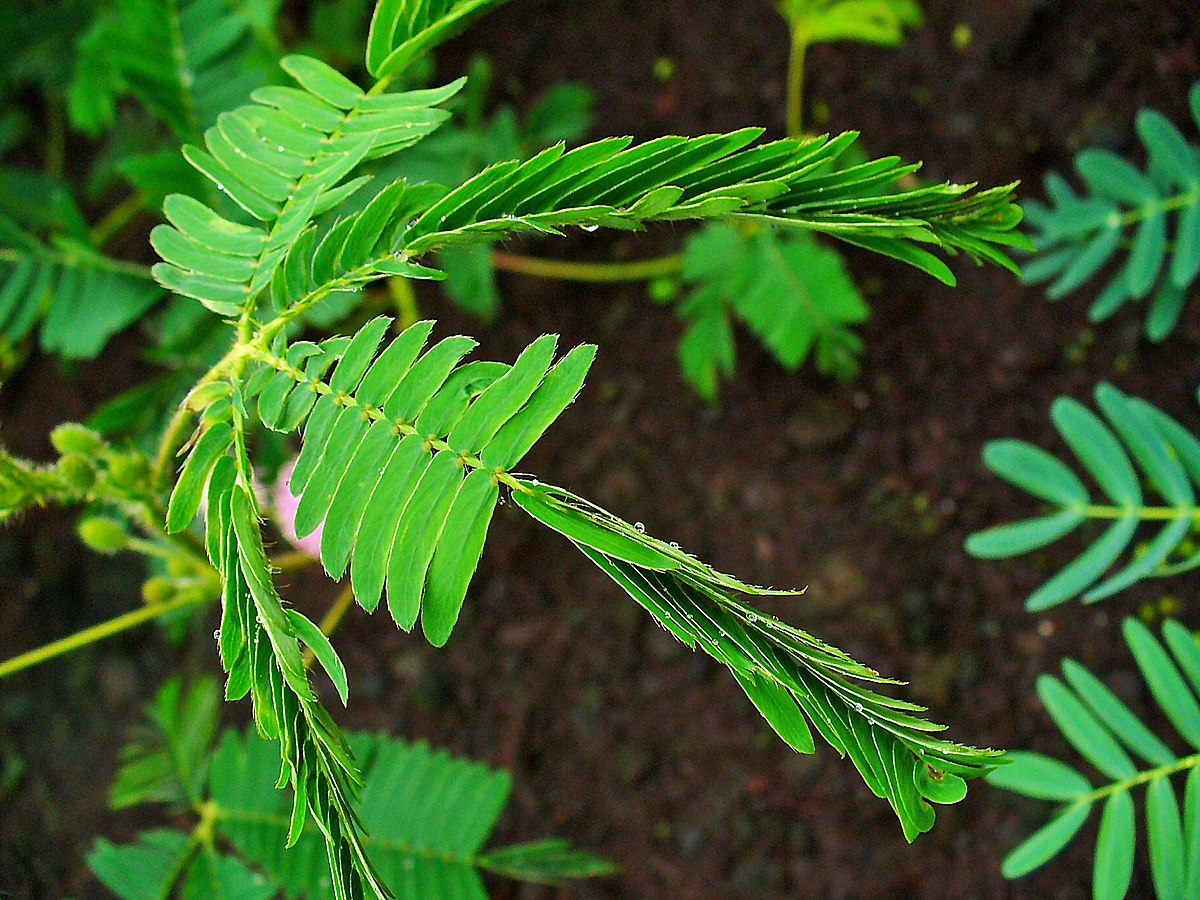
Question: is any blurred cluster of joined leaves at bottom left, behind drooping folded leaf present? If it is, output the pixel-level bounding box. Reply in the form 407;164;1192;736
88;678;613;900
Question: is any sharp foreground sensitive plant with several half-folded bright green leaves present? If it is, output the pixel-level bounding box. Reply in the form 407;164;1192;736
4;0;1021;898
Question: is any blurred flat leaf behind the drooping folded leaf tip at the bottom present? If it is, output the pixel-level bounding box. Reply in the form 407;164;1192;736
212;732;612;900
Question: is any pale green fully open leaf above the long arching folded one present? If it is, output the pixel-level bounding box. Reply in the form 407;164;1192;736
151;56;462;316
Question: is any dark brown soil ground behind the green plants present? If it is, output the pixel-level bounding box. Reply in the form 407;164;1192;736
0;0;1200;900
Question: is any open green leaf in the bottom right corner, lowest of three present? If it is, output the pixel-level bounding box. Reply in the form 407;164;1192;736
988;619;1200;900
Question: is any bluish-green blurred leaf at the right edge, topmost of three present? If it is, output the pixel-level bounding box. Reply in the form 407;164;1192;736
1025;84;1200;341
